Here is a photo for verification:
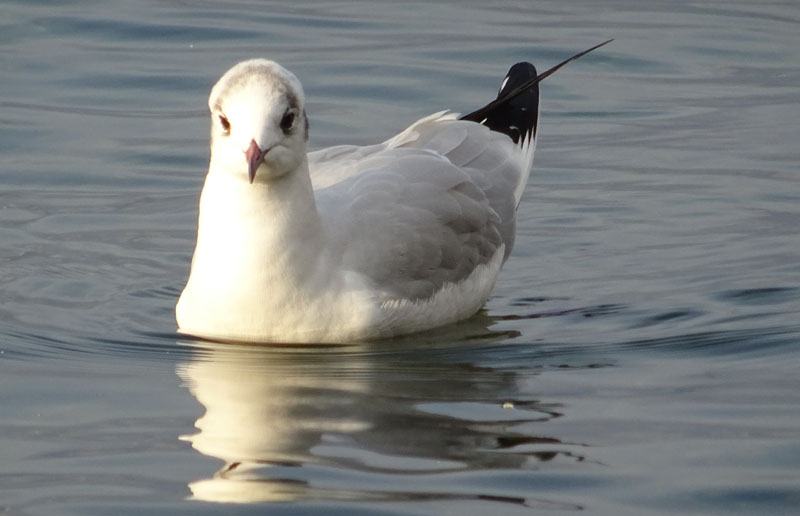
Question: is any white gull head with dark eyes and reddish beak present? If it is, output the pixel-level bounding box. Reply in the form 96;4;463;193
208;59;308;184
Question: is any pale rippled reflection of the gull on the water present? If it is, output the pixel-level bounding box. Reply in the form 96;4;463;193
178;316;582;505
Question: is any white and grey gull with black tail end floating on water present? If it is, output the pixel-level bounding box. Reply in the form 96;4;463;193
176;40;611;344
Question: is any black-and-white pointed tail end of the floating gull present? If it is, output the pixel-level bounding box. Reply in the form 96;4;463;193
461;39;614;205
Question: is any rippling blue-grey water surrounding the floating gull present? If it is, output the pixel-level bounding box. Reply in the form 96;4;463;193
0;0;800;516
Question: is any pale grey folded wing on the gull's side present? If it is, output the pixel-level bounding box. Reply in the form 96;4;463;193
309;111;522;299
